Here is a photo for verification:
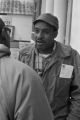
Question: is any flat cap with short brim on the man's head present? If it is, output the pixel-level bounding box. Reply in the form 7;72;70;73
33;13;59;29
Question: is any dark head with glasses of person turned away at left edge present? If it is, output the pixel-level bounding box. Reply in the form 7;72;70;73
0;18;10;48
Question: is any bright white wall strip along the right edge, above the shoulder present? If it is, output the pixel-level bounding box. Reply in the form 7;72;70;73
70;0;80;53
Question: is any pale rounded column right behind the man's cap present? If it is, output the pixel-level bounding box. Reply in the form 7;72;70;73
54;0;67;43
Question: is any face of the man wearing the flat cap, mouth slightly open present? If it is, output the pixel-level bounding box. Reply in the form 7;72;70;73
35;21;55;51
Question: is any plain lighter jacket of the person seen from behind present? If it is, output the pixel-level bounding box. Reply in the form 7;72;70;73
0;46;54;120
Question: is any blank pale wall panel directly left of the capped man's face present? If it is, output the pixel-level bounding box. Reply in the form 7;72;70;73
12;15;32;41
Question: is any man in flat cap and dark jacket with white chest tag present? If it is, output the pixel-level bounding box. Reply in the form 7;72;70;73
19;13;80;120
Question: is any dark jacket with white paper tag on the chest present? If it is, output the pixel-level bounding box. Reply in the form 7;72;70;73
19;41;80;120
